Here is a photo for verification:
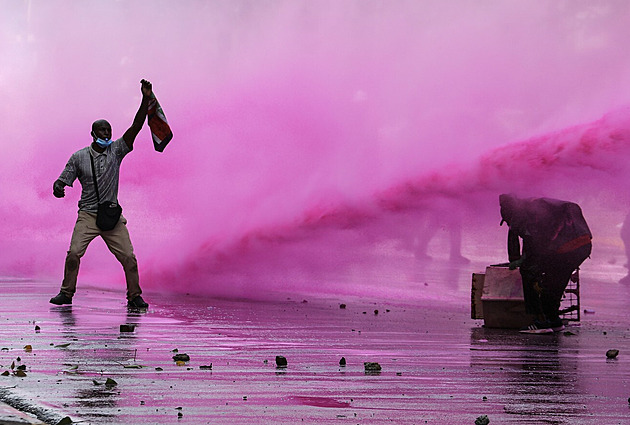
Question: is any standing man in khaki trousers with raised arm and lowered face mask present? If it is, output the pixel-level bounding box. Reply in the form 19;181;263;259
50;80;153;309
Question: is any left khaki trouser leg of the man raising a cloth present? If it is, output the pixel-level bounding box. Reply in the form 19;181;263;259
60;211;100;298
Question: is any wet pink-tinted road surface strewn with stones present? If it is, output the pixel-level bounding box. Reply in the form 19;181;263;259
0;272;630;425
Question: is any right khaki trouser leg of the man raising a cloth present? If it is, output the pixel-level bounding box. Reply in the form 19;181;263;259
101;216;142;301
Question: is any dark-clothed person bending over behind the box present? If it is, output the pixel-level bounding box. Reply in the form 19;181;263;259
499;194;592;333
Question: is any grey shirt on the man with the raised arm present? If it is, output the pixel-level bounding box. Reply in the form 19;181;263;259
59;137;131;212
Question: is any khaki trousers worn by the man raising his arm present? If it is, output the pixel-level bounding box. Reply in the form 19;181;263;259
61;211;142;300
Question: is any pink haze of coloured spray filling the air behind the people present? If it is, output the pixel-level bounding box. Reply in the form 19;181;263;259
0;0;630;299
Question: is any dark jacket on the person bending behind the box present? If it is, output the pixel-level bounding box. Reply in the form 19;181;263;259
499;194;593;262
